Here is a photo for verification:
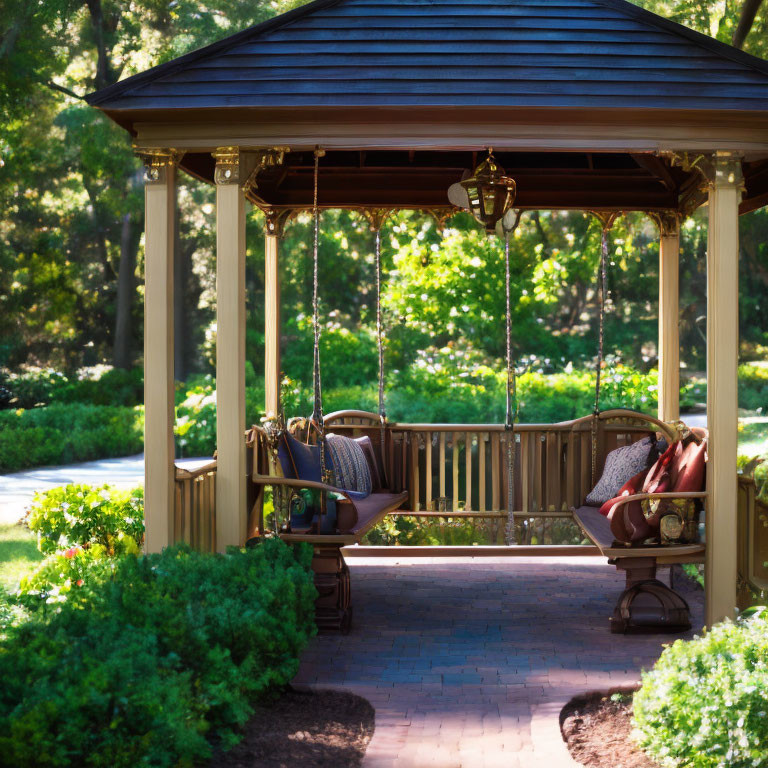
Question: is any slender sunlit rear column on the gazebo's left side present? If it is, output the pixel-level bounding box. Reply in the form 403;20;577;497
264;210;290;418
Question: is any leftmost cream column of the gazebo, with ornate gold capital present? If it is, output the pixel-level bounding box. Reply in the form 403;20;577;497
141;149;180;552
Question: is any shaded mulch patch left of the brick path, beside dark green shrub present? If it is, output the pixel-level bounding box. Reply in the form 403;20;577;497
209;689;374;768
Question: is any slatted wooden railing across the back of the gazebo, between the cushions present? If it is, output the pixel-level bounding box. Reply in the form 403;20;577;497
327;411;669;518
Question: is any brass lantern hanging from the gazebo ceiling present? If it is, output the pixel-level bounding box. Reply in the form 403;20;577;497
448;148;517;233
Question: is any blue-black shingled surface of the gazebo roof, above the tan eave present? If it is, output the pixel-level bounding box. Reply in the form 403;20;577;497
88;0;768;111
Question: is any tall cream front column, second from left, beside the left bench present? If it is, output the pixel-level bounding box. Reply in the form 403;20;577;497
213;147;247;552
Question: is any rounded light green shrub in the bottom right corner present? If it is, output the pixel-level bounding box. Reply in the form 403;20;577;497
634;613;768;768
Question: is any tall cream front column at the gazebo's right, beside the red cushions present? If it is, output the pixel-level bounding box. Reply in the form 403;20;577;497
706;152;743;626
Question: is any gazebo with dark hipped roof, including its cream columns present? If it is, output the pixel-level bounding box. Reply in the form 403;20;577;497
88;0;768;623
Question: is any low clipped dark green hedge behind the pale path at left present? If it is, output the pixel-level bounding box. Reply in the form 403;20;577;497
0;403;144;472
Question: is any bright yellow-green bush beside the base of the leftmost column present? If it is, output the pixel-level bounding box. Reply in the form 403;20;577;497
27;485;144;555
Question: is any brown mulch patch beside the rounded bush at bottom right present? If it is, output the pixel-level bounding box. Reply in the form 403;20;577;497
560;693;659;768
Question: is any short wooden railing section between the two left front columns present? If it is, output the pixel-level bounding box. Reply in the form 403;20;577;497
173;459;216;552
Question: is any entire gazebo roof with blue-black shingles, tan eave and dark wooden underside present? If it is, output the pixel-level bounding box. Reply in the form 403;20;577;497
88;0;768;210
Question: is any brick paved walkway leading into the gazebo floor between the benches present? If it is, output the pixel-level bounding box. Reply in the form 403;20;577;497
294;558;703;768
